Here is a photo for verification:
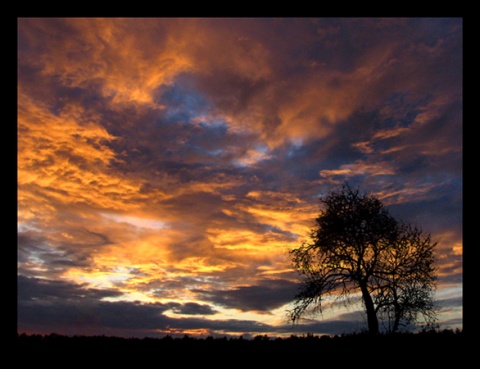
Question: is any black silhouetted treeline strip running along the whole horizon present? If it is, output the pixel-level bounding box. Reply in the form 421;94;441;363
17;329;463;354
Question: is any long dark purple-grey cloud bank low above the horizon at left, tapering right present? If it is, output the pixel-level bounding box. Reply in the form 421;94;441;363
18;276;272;337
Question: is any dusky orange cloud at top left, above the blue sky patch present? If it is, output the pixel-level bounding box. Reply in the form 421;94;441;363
21;18;190;104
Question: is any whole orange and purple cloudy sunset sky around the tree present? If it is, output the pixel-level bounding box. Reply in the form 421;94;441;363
17;18;463;337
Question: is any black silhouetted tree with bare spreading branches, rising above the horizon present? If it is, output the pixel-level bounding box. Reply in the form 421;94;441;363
289;184;436;334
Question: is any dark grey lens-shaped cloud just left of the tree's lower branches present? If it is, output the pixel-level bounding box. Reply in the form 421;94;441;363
195;280;298;312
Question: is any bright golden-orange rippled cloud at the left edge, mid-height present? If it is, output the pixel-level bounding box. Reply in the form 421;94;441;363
18;94;156;221
